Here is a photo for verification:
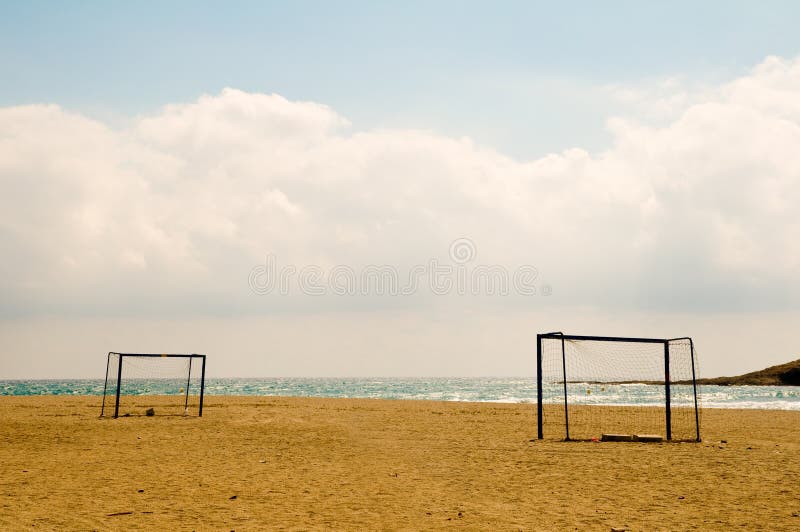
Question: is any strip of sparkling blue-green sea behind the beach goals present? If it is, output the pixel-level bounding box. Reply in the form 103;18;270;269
0;377;800;410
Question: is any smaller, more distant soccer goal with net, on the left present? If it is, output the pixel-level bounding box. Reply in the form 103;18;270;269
100;352;206;417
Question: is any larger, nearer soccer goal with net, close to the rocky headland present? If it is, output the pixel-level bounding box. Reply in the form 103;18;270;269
536;332;700;441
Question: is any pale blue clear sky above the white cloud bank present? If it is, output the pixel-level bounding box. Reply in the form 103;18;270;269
0;1;800;158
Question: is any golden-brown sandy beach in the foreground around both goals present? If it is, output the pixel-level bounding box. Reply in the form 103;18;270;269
0;396;800;531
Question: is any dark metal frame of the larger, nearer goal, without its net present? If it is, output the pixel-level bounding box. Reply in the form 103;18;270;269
536;332;700;442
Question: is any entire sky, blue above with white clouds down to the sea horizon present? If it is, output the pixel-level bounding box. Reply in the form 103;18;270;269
0;2;800;379
